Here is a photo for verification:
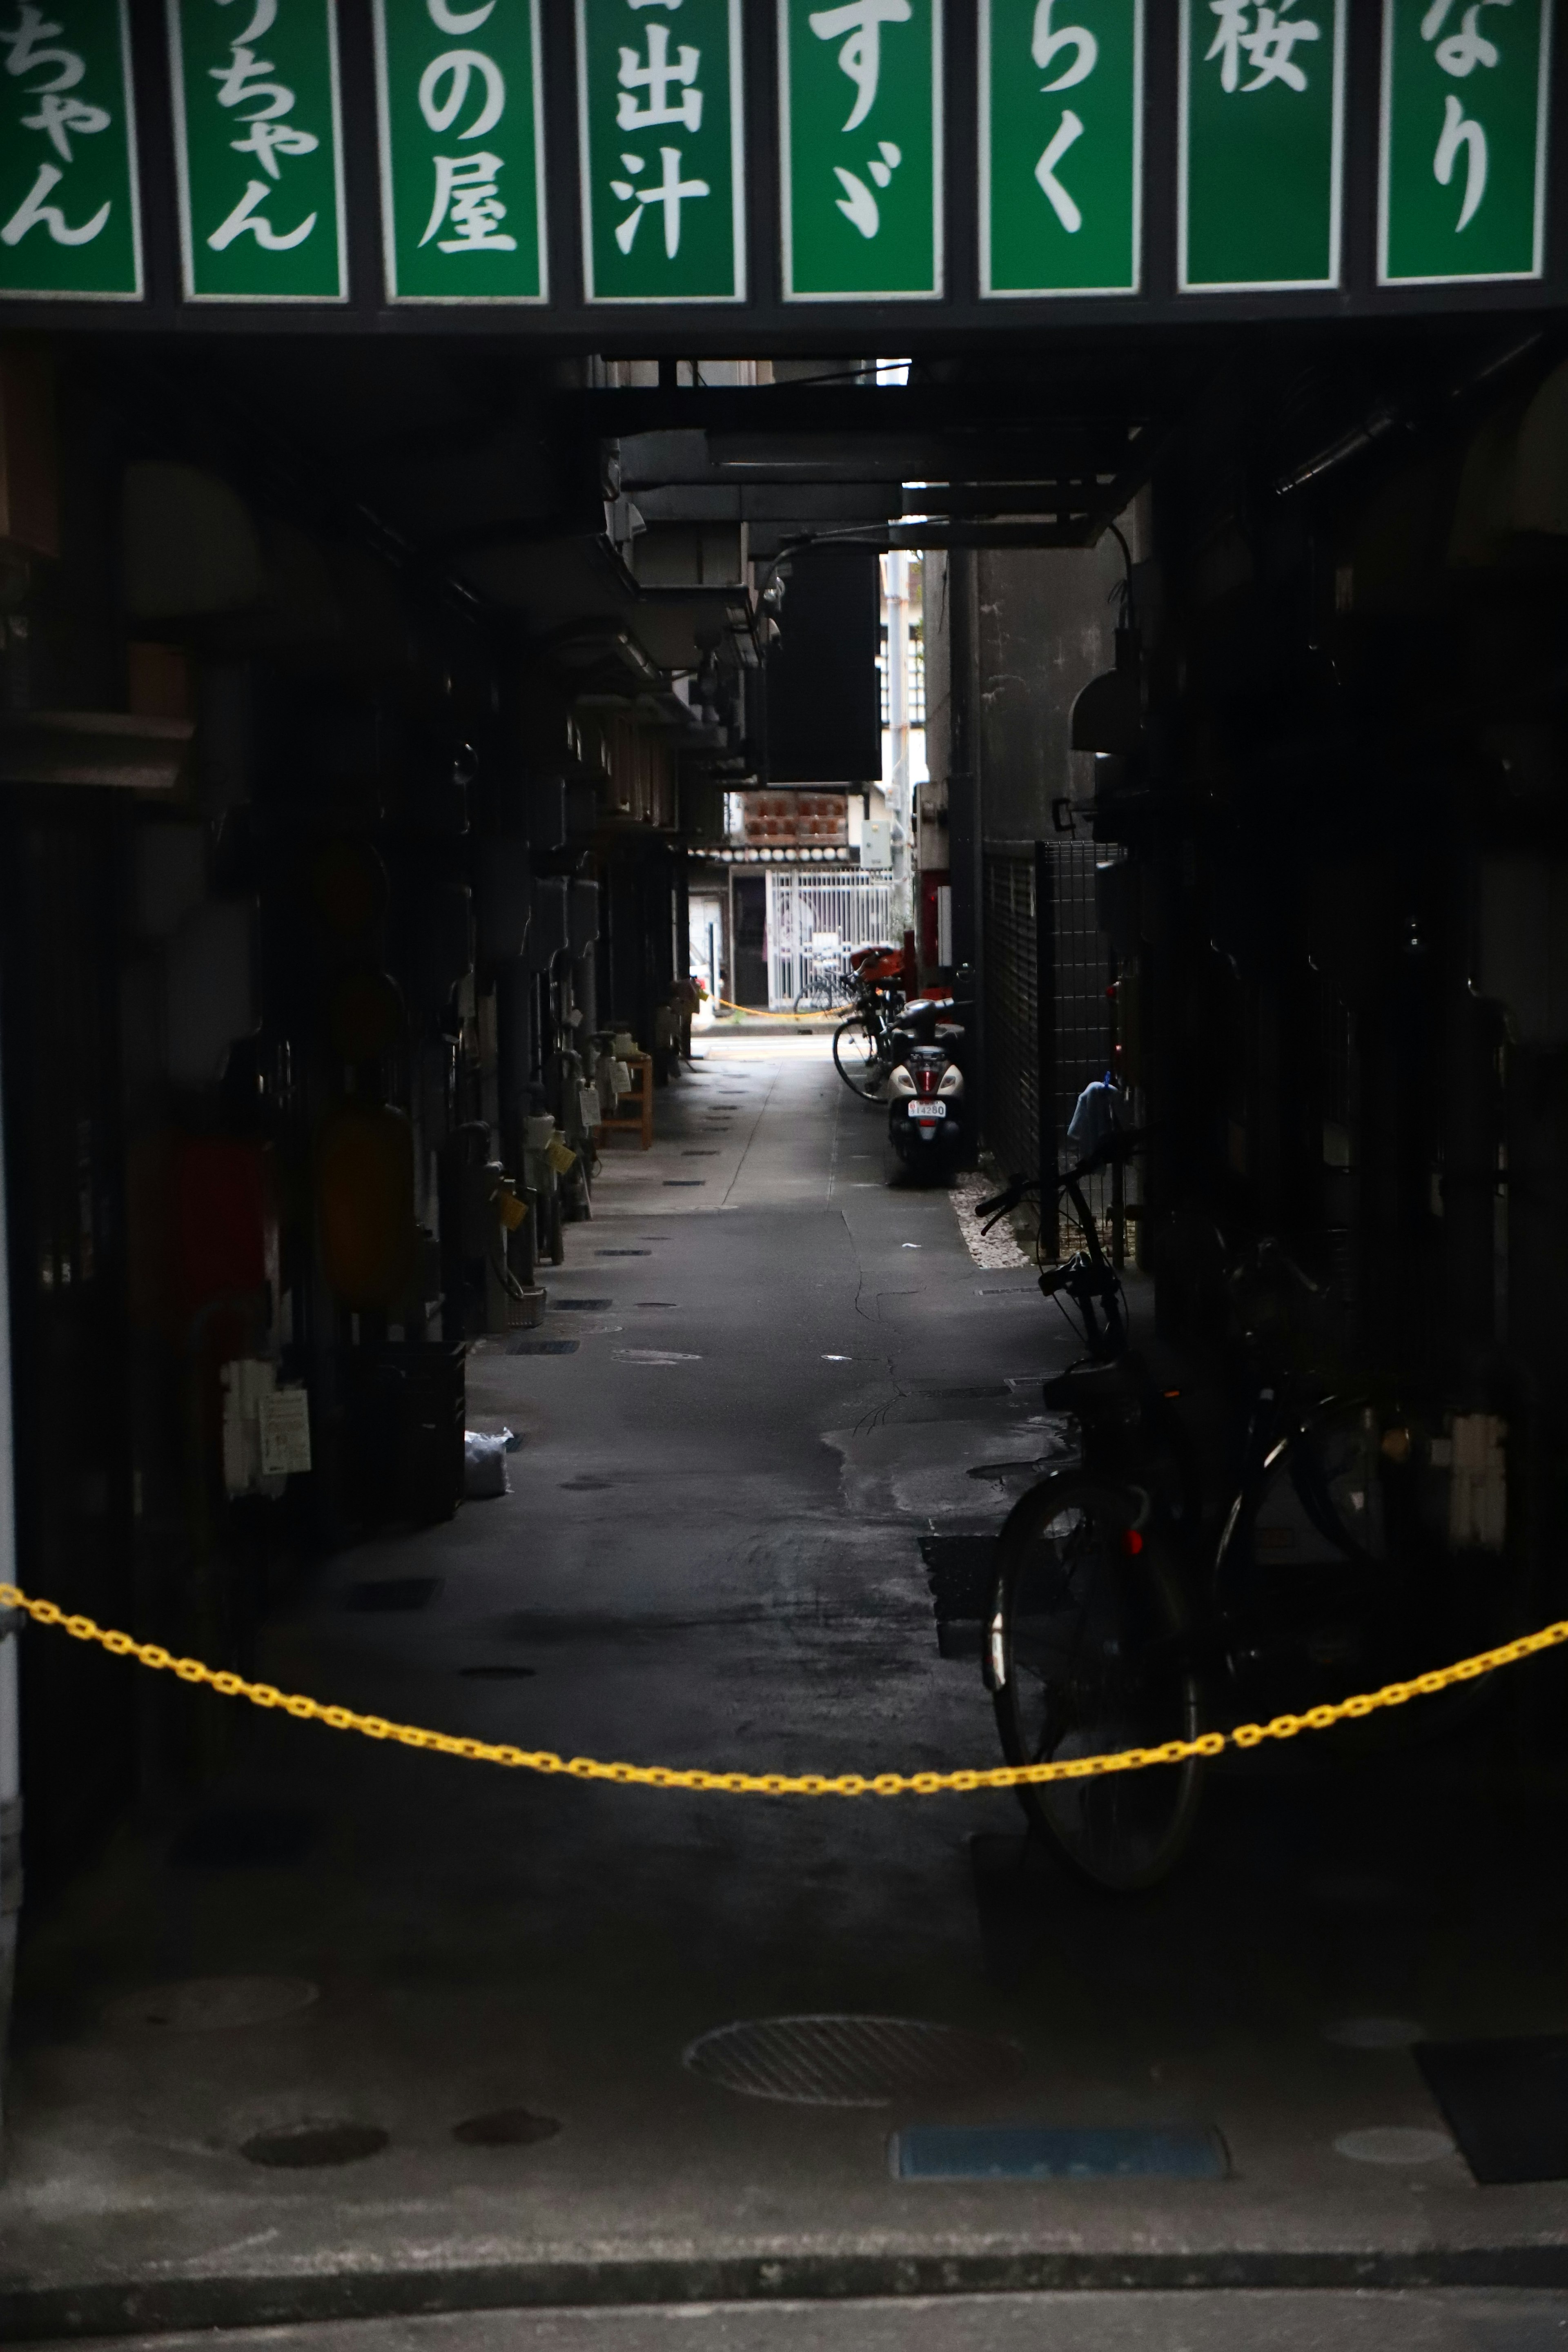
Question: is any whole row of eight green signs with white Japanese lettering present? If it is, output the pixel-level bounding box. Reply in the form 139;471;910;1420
0;0;1552;303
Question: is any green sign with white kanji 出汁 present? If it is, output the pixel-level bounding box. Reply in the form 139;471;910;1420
576;0;745;303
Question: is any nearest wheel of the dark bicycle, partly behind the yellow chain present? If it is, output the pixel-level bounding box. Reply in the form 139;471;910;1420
990;1470;1204;1893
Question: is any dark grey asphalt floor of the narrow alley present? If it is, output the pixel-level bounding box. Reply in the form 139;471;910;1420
0;1037;1568;2345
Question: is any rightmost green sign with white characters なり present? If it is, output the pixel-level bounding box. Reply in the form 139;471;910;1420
1378;0;1552;285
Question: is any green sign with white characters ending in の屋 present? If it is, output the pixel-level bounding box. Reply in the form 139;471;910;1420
376;0;548;301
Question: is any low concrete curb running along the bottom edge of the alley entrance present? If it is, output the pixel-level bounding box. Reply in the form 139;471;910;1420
0;2239;1568;2352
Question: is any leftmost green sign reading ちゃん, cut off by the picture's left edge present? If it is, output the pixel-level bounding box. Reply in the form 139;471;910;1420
0;0;141;301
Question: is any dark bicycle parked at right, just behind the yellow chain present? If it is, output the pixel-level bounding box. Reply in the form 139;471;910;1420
980;1134;1514;1893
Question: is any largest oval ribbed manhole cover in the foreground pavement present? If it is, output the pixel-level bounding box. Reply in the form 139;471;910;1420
684;2018;1022;2107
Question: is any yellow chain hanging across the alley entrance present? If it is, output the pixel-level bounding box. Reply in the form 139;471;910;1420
0;1585;1568;1797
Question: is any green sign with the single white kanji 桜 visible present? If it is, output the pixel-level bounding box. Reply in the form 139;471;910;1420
1178;0;1347;294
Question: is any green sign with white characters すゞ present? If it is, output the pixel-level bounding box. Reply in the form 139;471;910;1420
778;0;943;301
